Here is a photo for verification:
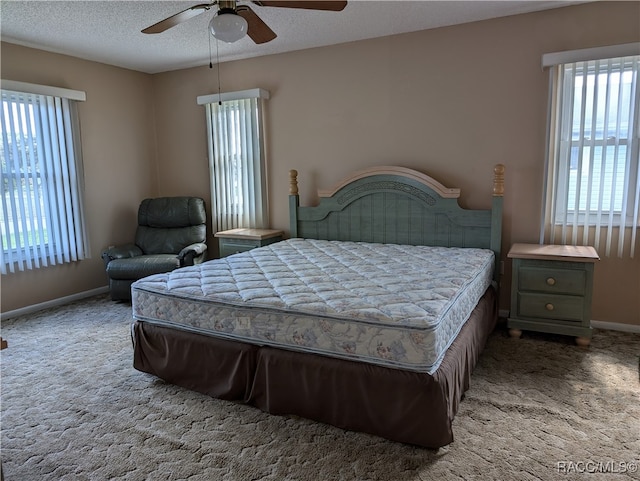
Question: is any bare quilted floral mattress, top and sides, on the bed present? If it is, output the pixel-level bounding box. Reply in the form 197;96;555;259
131;239;494;373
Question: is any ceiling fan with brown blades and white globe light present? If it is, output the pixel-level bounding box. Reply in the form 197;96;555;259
142;0;347;44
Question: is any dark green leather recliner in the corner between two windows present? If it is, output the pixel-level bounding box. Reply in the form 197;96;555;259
102;197;207;300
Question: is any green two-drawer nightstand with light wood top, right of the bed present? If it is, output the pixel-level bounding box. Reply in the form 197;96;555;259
507;244;600;346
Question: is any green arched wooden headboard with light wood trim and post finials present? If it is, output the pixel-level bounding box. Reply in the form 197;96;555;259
289;164;504;281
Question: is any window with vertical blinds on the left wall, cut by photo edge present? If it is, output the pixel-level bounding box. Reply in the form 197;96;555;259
0;80;89;274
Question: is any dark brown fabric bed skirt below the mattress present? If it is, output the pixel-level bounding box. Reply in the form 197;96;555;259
132;288;497;448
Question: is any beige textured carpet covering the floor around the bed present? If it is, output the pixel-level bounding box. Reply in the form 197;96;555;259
1;296;640;481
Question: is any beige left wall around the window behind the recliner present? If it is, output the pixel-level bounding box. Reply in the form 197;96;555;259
0;43;158;312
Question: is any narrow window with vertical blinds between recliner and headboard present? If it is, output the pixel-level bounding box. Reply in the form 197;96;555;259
198;89;269;231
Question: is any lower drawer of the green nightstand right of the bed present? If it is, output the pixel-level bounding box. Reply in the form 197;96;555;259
518;292;585;322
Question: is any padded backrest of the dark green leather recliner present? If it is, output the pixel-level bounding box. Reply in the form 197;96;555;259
135;197;207;254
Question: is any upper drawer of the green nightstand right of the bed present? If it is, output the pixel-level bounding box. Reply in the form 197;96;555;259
518;266;587;296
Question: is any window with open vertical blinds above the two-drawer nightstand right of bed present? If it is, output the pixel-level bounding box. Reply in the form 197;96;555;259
542;47;640;257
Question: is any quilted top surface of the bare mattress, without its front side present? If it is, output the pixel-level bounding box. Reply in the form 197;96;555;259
134;239;494;329
